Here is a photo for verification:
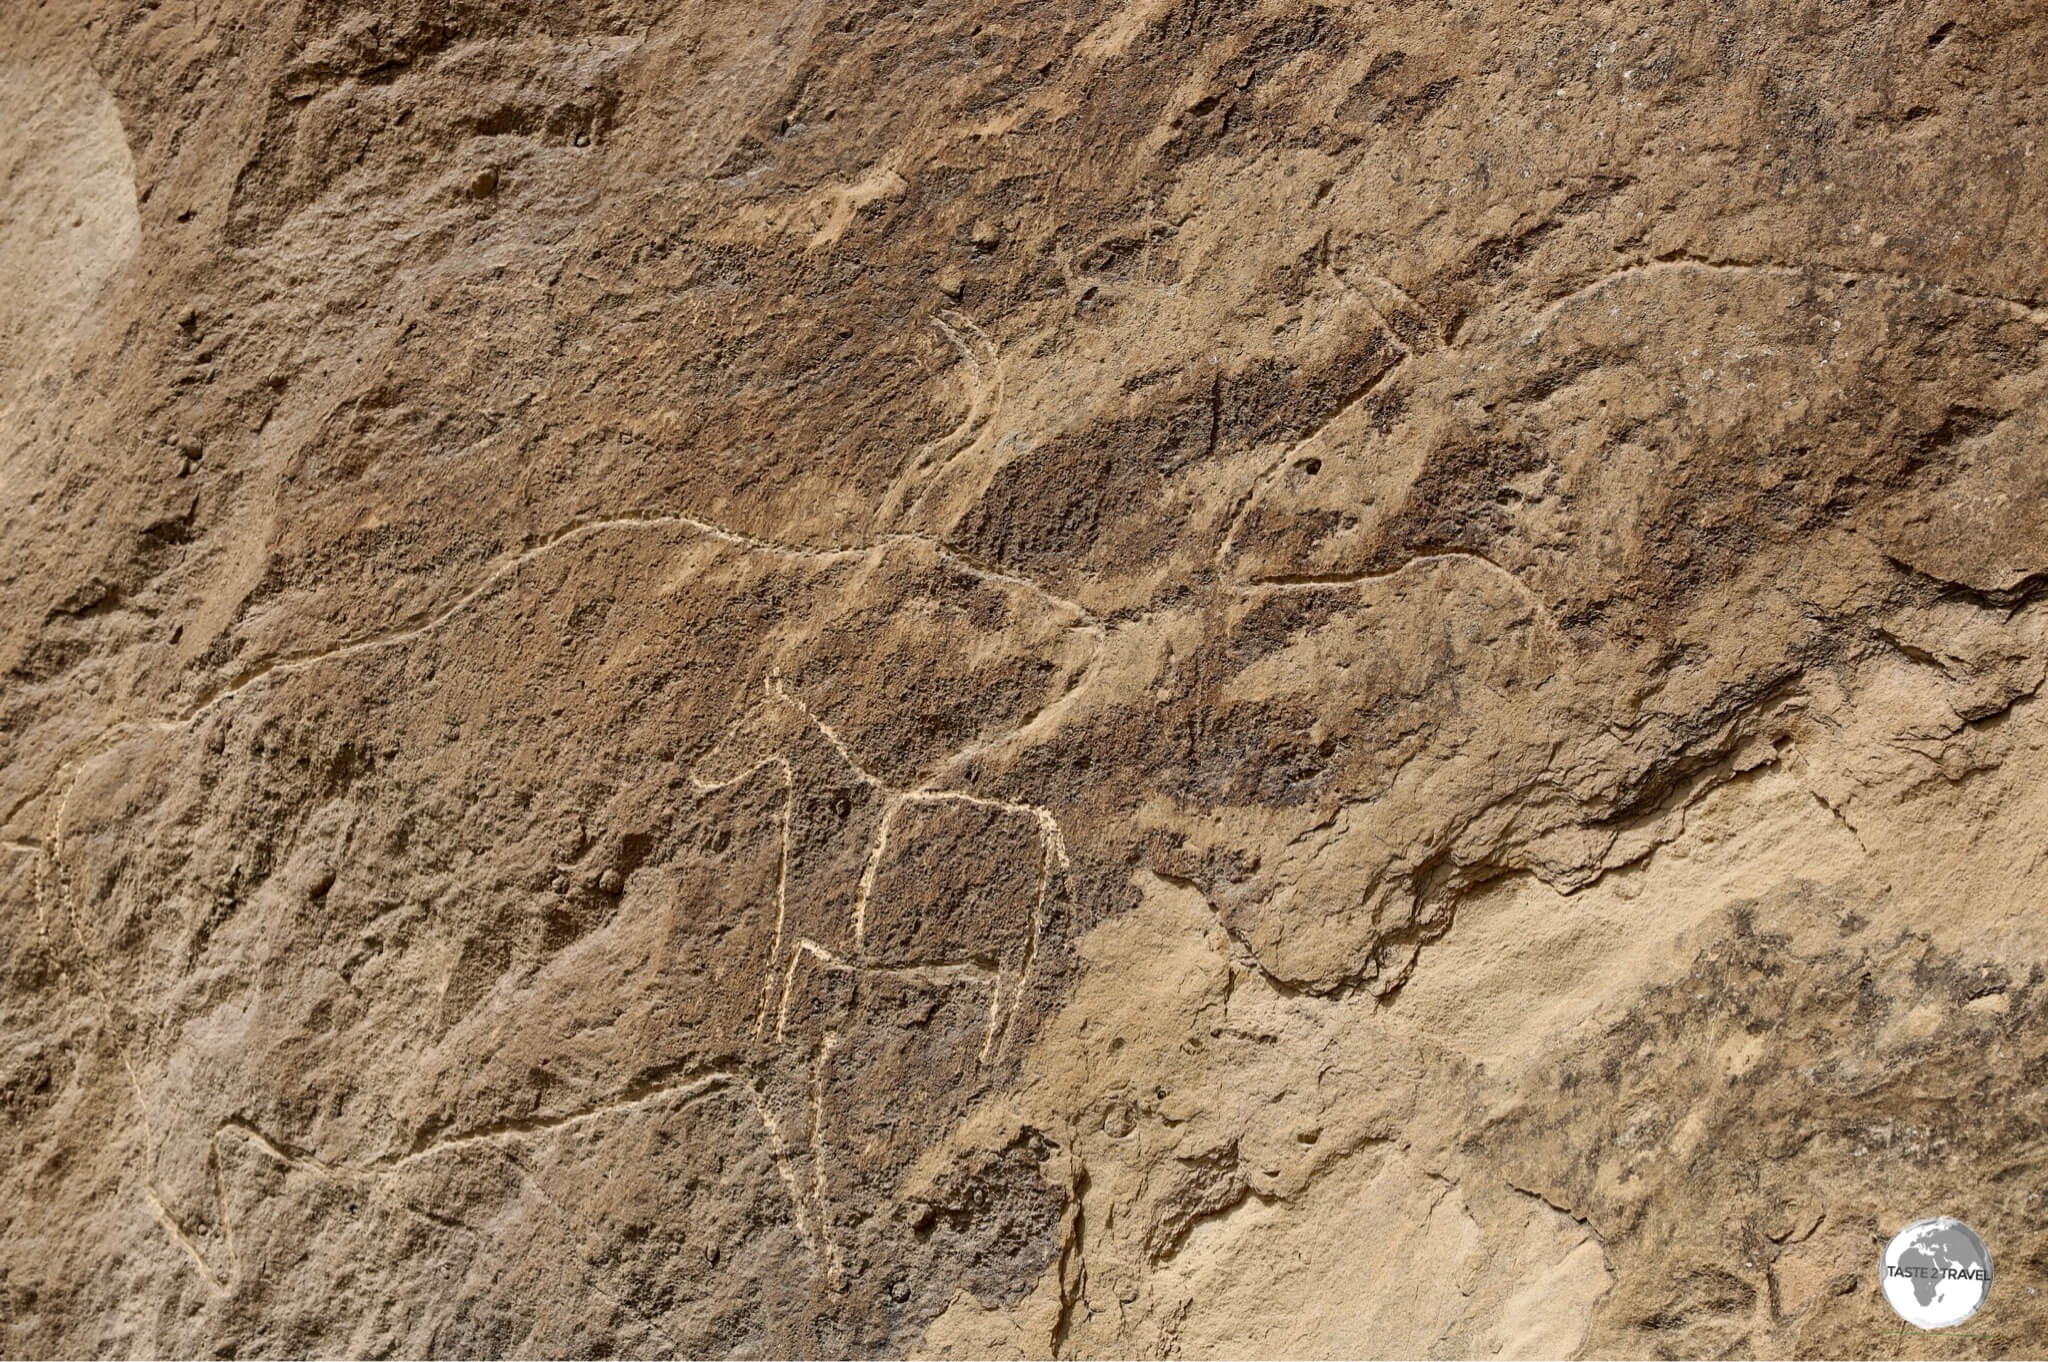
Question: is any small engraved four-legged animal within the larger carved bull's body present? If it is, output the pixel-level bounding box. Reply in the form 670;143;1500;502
690;678;1067;1059
